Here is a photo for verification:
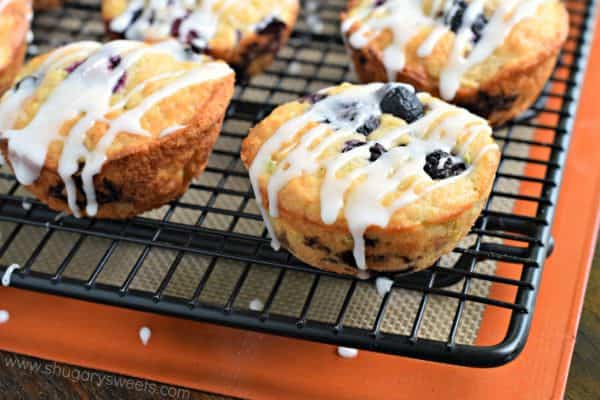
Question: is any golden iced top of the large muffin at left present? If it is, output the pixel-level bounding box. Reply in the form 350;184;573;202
0;41;233;215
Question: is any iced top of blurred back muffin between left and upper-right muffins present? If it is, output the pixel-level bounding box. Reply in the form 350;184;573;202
102;0;298;53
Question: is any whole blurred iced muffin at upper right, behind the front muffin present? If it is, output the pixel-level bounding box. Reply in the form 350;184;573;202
342;0;569;125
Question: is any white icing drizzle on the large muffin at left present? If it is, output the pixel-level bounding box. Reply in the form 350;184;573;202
0;41;232;216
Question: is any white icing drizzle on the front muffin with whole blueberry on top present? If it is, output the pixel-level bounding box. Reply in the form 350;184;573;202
250;83;497;270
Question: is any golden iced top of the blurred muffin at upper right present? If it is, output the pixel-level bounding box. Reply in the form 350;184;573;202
342;0;568;100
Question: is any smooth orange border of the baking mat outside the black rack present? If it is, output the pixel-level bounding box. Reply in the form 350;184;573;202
0;9;600;400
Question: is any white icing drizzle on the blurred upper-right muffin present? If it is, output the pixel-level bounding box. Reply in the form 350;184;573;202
342;0;546;101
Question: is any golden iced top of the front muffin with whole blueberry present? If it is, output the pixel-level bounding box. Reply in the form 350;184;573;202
242;83;499;266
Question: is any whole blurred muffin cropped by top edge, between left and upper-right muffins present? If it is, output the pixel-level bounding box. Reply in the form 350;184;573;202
102;0;299;76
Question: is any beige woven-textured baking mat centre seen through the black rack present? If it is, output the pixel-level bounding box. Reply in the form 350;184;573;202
0;0;544;344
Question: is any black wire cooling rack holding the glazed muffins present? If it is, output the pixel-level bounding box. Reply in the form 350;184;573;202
0;0;595;366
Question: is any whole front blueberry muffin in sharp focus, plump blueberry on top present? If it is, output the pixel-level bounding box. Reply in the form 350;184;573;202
242;83;500;276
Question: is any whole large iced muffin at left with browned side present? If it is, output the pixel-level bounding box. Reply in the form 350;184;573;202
0;41;235;219
